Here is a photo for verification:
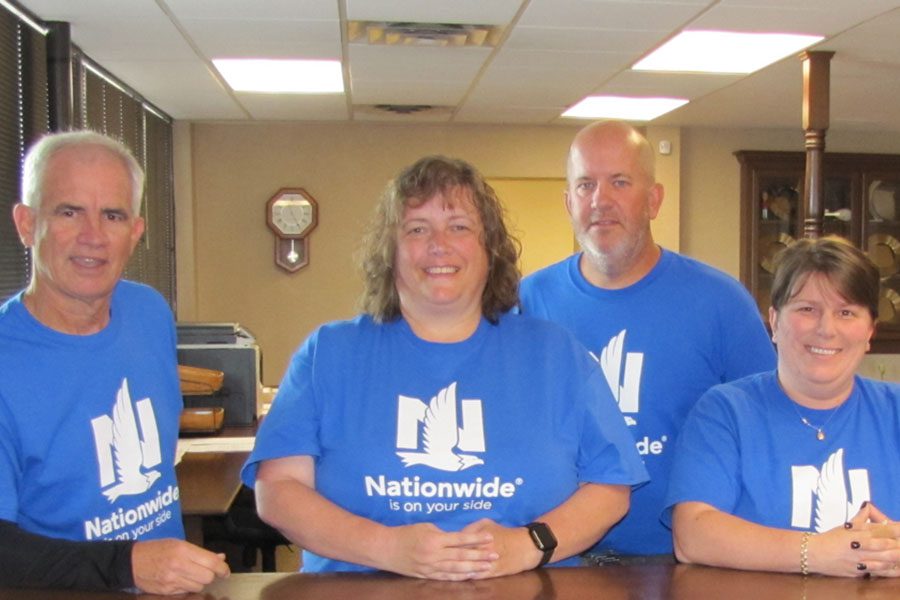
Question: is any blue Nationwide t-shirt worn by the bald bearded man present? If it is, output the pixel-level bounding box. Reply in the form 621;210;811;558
521;250;775;554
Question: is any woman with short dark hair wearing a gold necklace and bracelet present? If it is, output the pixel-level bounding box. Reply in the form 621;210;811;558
664;237;900;577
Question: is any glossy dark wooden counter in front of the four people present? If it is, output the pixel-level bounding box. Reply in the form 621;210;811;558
0;565;900;600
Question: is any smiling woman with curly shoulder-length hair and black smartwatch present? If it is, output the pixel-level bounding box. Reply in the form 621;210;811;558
243;157;647;580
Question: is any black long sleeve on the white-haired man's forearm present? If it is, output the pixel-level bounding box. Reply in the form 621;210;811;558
0;520;134;591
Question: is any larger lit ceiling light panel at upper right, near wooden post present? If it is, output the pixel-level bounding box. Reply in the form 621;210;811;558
632;31;824;73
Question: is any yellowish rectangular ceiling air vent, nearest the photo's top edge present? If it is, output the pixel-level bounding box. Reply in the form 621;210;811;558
347;21;503;47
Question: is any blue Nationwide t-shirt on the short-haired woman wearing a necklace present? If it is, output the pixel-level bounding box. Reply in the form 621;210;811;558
663;371;900;532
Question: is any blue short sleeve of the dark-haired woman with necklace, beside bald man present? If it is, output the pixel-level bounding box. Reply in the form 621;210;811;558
662;387;741;527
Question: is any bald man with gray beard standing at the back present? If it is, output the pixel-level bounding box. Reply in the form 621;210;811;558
521;121;775;563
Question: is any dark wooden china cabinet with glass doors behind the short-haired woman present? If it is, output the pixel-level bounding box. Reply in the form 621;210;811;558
735;150;900;353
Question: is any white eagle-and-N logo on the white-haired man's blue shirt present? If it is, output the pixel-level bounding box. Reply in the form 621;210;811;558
91;379;162;502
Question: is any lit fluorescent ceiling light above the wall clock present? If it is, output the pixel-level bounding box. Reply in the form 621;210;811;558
213;58;344;94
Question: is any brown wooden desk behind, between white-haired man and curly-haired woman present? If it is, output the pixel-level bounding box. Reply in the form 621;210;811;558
175;452;249;546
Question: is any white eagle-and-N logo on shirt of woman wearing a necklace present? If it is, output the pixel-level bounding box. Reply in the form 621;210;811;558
791;448;871;533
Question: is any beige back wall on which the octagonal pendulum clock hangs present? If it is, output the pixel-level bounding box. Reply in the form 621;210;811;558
175;123;900;385
